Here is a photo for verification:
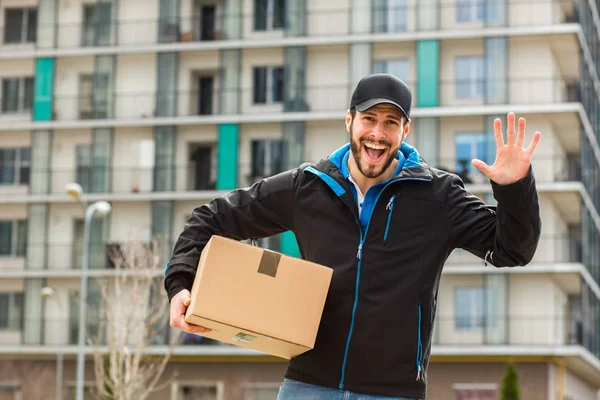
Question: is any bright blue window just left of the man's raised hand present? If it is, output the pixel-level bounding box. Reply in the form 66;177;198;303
454;133;496;183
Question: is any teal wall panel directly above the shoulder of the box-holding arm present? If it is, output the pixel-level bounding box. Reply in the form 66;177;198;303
217;124;239;190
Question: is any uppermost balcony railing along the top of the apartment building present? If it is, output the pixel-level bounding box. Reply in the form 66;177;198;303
0;0;579;51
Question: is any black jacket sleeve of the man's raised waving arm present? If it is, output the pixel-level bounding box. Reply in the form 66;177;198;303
446;167;542;267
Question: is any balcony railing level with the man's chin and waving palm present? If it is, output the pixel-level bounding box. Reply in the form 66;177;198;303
0;152;582;198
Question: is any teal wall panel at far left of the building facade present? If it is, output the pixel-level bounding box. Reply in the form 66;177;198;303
33;58;54;121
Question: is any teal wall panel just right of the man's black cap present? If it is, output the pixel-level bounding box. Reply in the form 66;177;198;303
416;40;440;107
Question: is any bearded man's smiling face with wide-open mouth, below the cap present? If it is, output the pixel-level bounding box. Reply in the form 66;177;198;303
346;104;410;179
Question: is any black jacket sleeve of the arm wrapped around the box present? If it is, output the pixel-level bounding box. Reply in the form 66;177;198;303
164;168;300;302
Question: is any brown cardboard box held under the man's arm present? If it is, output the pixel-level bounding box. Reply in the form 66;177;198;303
185;236;333;359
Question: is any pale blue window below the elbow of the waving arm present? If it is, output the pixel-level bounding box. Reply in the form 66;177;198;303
454;287;484;330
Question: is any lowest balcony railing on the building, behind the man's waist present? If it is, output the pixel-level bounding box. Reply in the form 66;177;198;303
0;316;600;353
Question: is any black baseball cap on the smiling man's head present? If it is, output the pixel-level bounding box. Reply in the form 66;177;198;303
350;74;412;121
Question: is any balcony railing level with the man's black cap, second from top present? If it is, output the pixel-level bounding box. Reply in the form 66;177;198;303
42;76;580;121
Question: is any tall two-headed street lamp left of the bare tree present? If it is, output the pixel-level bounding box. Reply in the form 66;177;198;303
65;183;111;400
